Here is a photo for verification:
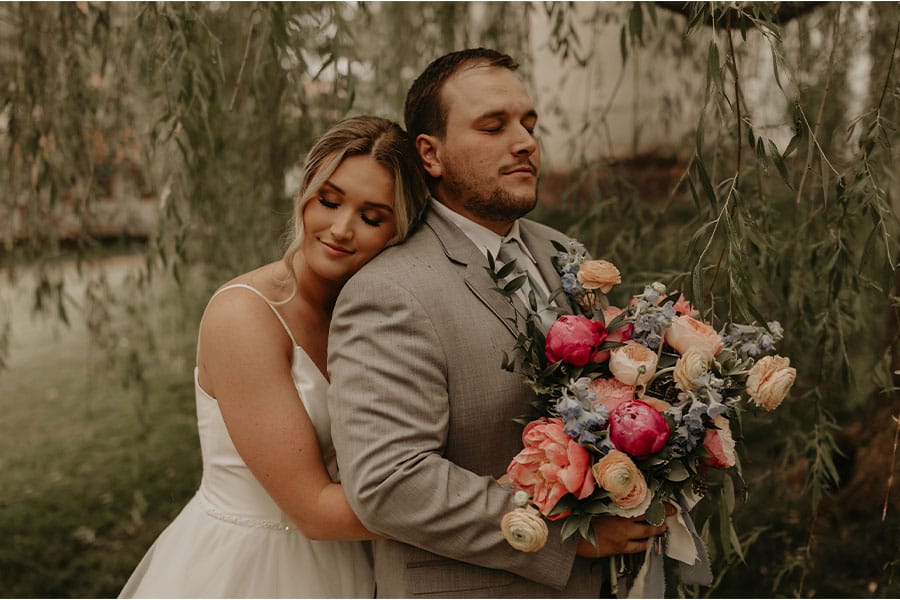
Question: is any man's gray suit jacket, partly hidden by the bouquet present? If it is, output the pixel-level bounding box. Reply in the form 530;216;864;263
328;205;603;598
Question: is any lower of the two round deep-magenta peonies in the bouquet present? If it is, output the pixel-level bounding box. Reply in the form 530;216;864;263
609;400;669;460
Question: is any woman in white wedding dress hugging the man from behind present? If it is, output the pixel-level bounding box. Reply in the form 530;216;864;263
120;117;427;598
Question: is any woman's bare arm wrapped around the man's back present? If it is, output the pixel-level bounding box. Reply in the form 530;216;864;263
198;292;378;540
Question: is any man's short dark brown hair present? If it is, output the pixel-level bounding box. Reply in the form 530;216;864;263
403;48;519;143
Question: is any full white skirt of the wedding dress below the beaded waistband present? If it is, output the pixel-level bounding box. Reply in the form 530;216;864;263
119;492;375;598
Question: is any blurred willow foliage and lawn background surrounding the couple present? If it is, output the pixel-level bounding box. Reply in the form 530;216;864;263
0;2;900;597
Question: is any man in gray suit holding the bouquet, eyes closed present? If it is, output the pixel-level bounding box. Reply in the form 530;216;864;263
328;48;663;598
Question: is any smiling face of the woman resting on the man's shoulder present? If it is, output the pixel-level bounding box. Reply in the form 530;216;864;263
303;156;397;281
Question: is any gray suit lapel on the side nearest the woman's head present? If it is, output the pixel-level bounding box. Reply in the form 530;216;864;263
425;206;525;337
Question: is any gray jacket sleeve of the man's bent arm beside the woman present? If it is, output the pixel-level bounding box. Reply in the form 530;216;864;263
328;270;576;589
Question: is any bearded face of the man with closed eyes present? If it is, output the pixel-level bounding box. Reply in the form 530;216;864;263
426;65;540;235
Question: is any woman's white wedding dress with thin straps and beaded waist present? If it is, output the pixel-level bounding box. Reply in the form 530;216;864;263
119;284;374;598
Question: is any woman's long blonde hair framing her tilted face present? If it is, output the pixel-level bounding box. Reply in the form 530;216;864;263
279;116;428;304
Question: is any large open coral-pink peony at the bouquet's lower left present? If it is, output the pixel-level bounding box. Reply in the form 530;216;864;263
506;417;594;520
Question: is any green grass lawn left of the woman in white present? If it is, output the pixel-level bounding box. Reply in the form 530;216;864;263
0;260;200;598
